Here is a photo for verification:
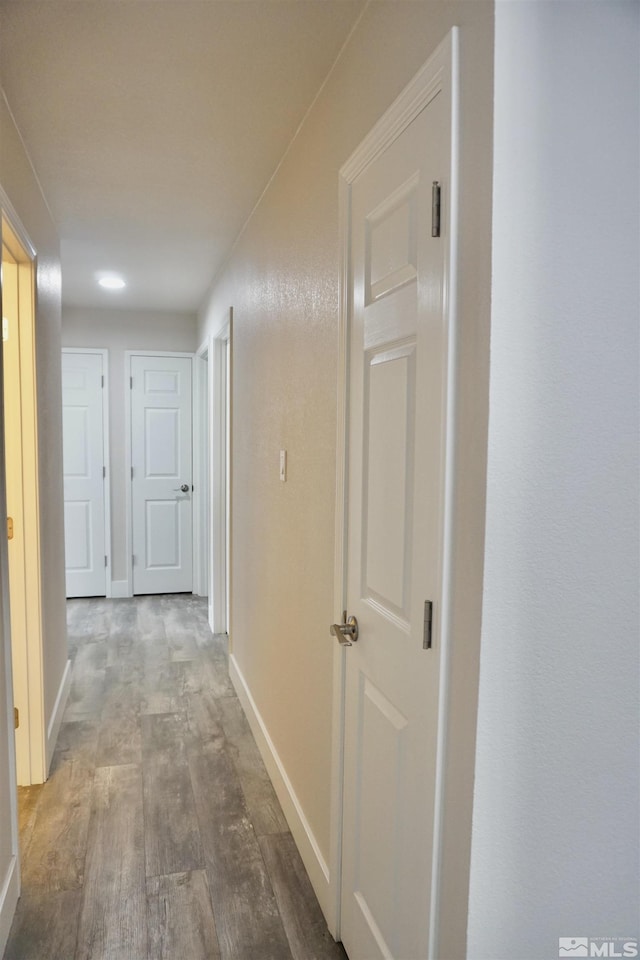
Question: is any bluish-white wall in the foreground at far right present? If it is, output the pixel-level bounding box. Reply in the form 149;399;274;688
468;2;640;960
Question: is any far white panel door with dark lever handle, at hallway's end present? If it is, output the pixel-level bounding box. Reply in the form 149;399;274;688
131;356;193;594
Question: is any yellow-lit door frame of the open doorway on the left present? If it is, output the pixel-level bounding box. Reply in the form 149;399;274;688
0;197;50;784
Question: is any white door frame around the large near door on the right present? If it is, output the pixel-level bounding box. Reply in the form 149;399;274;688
325;27;459;960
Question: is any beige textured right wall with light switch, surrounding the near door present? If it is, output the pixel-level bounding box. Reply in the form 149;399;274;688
200;0;493;957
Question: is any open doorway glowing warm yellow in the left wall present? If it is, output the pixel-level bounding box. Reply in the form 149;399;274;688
2;213;47;786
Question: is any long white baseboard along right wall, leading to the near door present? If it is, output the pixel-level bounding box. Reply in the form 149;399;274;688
229;654;333;917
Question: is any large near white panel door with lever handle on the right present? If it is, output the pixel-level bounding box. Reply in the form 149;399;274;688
342;71;451;960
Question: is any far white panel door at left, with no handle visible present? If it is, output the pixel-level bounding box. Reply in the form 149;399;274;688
62;352;107;597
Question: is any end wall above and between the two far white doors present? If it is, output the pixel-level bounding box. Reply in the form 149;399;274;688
62;307;198;583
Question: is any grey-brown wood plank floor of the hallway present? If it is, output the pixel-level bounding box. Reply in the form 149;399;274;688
4;594;346;960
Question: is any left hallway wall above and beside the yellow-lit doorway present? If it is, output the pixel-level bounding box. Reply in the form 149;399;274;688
0;98;67;756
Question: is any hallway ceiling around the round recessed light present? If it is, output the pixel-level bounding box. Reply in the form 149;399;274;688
0;0;364;311
